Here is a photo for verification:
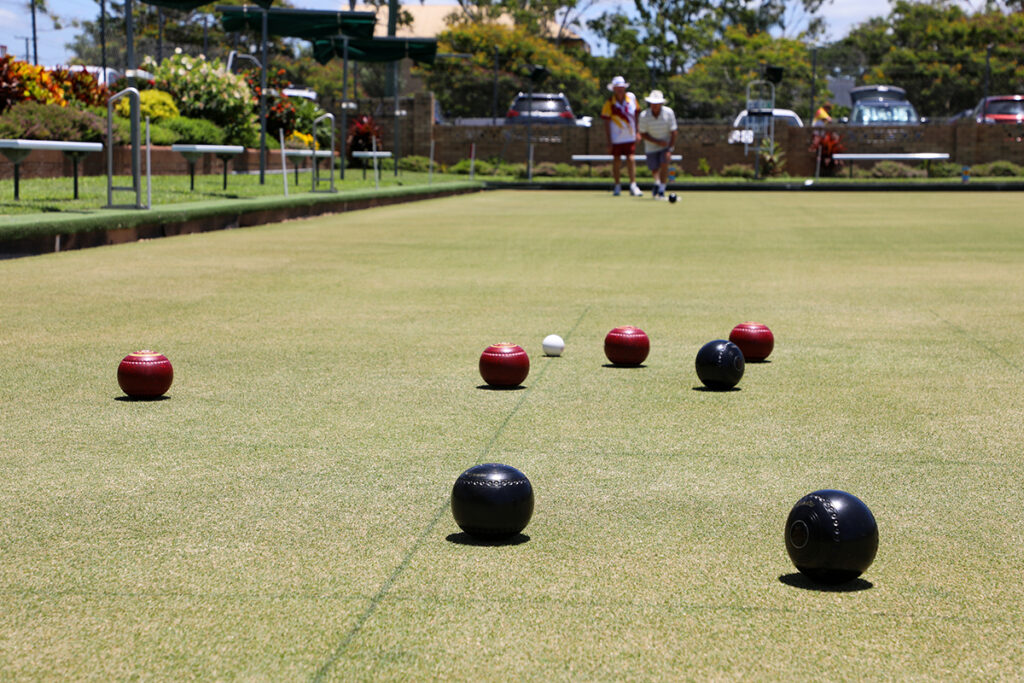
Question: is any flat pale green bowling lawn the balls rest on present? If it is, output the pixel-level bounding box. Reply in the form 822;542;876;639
0;191;1024;681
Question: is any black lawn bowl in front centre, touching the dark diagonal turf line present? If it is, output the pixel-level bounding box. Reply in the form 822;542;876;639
452;463;534;541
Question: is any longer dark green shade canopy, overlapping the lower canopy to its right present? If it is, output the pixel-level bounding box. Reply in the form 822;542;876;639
216;5;377;40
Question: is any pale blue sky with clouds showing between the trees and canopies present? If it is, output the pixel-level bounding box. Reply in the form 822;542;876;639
0;0;889;66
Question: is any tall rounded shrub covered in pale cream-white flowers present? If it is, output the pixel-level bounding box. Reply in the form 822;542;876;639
142;53;258;146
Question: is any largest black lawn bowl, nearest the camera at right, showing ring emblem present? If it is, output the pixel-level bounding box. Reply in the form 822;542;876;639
785;488;879;585
